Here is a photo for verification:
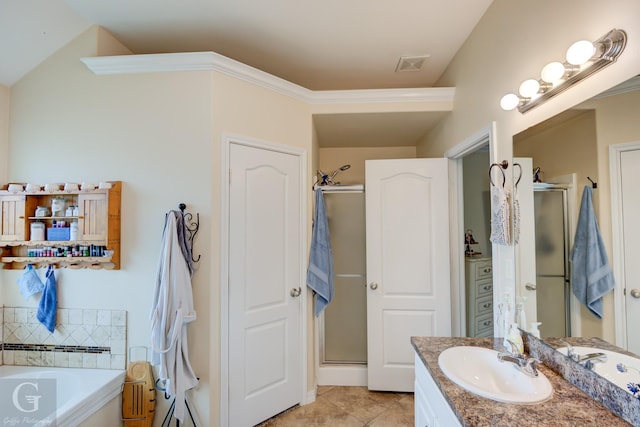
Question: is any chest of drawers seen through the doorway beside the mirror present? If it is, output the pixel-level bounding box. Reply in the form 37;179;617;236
465;258;493;337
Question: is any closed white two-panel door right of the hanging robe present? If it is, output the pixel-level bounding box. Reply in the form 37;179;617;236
229;144;302;427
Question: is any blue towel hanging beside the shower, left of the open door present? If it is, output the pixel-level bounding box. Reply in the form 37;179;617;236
307;188;333;316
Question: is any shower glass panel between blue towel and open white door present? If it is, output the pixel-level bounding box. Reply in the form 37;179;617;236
321;189;367;364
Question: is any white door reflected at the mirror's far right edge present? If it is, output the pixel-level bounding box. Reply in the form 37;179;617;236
620;150;640;354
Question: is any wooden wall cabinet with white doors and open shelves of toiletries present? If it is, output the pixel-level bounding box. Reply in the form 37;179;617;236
0;181;122;270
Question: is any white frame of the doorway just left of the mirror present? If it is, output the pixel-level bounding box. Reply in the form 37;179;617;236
444;122;496;337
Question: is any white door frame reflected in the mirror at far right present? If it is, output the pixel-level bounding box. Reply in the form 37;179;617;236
609;141;640;348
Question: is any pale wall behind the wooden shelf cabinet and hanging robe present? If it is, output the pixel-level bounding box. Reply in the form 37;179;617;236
5;25;218;424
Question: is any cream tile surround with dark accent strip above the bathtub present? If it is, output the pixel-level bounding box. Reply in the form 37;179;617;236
0;307;127;369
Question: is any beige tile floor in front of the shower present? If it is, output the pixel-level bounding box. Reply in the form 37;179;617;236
260;386;414;427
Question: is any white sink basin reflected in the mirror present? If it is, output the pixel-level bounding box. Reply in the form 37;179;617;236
558;346;640;393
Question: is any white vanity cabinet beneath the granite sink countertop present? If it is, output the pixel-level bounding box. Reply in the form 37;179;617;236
414;354;461;427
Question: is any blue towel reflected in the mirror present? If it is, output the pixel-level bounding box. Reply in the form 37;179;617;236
570;185;615;318
